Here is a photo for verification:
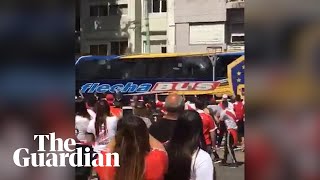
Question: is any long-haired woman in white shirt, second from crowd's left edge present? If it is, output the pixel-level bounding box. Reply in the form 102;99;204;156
87;100;118;152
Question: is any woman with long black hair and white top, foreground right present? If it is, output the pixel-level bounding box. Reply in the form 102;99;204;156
165;110;214;180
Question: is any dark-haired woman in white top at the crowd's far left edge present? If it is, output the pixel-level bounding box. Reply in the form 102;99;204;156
75;100;92;142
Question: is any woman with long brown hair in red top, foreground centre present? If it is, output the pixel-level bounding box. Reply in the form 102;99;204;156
96;116;168;180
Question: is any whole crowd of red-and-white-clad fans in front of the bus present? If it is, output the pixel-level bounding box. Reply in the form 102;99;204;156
75;94;245;180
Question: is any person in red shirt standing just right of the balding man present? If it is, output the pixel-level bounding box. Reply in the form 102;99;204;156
195;99;220;161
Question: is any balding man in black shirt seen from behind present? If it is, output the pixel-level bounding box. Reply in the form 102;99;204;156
149;94;184;143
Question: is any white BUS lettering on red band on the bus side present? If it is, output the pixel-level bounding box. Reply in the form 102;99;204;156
151;82;220;92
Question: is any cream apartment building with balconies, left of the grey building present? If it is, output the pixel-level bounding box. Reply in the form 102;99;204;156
80;0;167;55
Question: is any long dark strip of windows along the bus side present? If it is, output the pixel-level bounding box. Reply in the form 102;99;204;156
76;56;213;81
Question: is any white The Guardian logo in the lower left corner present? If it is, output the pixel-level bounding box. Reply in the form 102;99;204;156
13;133;120;167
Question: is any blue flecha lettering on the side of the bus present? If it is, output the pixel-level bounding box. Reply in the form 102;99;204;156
81;82;152;93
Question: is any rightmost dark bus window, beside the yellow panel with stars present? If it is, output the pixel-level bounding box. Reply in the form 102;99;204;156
215;55;240;81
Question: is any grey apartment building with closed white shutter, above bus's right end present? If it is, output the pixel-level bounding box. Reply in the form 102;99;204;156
170;0;244;52
